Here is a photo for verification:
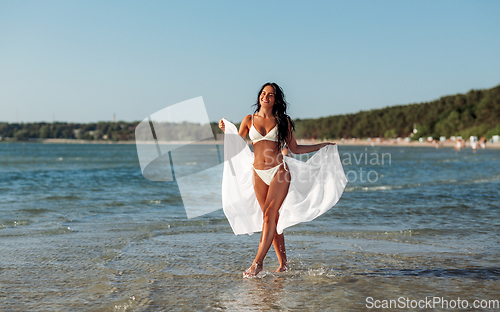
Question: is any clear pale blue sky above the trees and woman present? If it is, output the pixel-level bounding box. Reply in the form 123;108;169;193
0;0;500;122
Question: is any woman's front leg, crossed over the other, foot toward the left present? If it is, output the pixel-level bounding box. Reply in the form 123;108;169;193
243;167;290;276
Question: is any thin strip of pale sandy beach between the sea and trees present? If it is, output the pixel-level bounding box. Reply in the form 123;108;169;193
0;139;500;149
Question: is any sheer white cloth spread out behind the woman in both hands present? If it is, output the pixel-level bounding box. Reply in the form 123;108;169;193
222;119;347;235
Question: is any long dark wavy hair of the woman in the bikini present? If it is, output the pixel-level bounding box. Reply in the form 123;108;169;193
253;82;295;150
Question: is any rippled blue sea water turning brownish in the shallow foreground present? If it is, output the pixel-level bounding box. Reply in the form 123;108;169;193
0;143;500;311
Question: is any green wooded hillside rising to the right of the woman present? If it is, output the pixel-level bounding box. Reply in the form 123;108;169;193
295;85;500;139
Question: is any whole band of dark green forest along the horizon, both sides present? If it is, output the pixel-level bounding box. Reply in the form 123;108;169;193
0;85;500;141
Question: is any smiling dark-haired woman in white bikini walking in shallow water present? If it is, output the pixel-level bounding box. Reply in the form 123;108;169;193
219;83;346;277
